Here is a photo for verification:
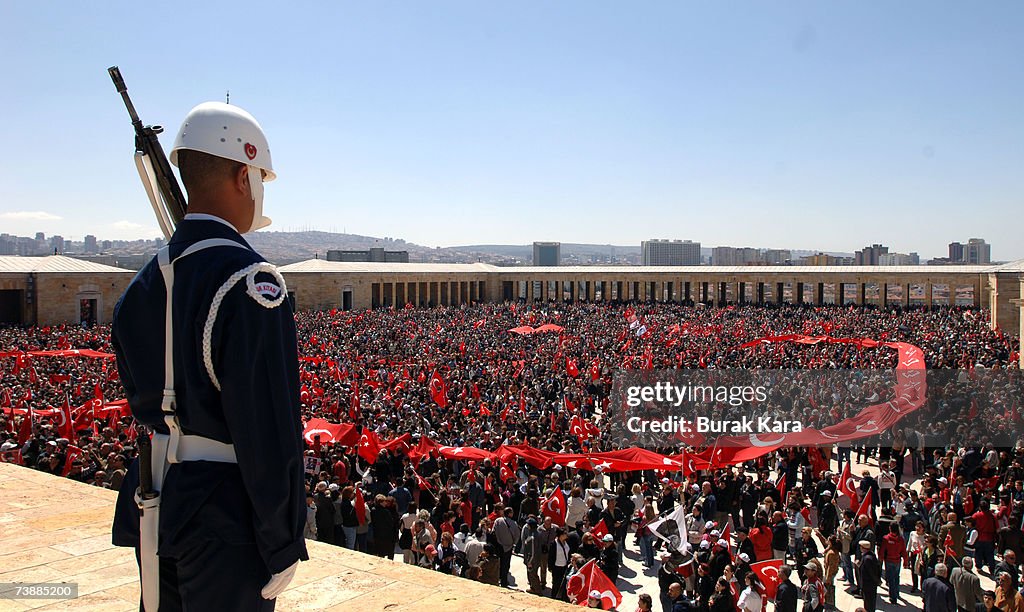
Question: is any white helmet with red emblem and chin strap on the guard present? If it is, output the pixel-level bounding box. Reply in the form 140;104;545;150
169;102;278;233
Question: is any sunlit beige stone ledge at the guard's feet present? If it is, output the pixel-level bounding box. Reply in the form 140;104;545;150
0;464;579;612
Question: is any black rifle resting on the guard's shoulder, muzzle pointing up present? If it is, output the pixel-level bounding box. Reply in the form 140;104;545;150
106;65;187;239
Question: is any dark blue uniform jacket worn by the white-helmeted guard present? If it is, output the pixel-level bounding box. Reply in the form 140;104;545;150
112;220;307;573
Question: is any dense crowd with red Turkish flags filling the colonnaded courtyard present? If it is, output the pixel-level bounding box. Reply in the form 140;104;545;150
0;303;1024;612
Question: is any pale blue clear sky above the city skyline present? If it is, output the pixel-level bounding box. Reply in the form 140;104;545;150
0;0;1024;260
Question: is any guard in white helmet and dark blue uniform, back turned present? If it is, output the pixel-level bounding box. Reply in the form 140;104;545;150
112;102;308;611
